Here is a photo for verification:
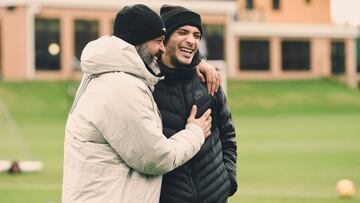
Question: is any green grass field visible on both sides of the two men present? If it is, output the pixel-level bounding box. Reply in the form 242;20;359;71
0;80;360;203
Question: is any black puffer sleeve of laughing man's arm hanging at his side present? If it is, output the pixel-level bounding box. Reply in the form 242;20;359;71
216;87;237;196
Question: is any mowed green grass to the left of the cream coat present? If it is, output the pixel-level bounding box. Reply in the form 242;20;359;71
0;82;70;203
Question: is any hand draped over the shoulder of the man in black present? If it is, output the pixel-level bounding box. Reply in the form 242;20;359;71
196;59;221;96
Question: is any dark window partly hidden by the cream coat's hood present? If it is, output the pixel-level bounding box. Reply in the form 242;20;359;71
75;20;99;60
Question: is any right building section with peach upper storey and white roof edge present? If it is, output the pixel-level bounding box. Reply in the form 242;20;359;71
229;0;358;87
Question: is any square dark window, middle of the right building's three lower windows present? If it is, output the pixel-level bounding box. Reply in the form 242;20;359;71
281;41;310;70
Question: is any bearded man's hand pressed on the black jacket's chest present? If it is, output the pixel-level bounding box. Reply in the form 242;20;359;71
187;105;212;139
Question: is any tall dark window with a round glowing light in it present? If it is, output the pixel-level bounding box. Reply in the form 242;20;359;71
35;18;61;70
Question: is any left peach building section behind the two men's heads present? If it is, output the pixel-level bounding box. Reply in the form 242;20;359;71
0;0;236;80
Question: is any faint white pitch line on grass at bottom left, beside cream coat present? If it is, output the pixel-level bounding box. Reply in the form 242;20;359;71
0;183;61;191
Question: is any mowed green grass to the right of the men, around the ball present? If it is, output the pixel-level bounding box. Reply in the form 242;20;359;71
228;80;360;203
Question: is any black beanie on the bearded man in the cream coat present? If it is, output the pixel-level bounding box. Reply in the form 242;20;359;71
113;4;166;46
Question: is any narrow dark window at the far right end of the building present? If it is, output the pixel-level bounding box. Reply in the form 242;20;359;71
331;42;345;74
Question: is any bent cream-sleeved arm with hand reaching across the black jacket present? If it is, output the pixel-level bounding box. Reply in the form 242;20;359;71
94;85;211;175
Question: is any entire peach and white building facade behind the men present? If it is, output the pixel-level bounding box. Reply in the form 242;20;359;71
0;0;358;87
